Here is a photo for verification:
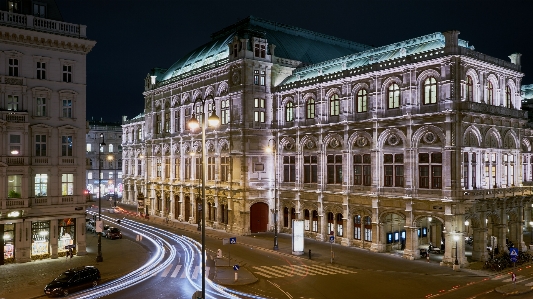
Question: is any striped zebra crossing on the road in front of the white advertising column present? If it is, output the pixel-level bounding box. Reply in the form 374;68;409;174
252;265;357;278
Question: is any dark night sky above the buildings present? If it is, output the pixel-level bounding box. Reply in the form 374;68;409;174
56;0;533;122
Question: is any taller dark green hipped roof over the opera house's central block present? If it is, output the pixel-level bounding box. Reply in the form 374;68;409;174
157;16;372;82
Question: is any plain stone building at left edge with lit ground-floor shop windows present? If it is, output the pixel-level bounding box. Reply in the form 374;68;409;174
0;1;95;264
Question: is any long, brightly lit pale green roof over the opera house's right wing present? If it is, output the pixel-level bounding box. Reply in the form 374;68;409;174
280;32;468;85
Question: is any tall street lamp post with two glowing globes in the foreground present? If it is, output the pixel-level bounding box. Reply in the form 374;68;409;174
189;99;220;299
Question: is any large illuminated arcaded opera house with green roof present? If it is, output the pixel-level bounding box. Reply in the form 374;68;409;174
123;17;533;265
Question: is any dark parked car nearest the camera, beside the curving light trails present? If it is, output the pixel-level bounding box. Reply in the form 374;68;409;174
44;266;100;297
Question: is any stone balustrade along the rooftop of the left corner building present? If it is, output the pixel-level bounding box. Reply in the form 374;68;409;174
0;11;87;38
